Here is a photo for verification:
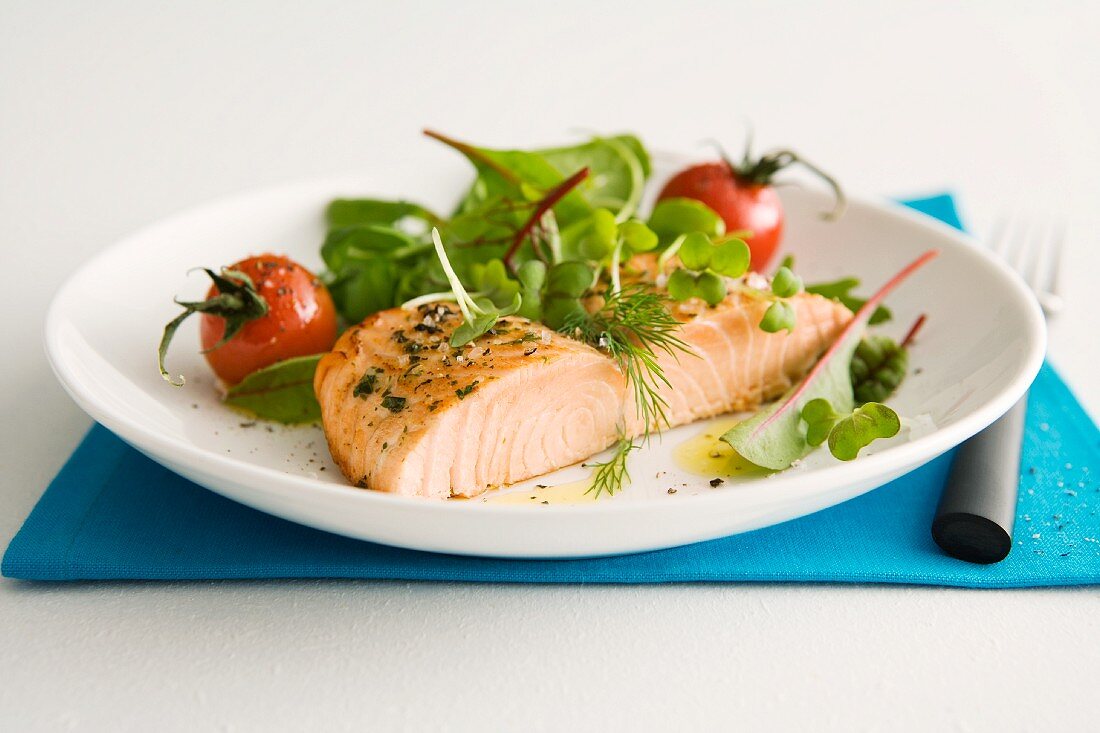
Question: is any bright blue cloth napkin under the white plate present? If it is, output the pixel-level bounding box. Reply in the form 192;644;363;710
2;196;1100;588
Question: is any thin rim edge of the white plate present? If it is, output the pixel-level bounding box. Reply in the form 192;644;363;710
44;174;1046;516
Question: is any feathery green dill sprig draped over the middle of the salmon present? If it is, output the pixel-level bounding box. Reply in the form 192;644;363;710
561;283;691;440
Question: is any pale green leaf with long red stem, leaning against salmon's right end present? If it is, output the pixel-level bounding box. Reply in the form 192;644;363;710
722;250;939;470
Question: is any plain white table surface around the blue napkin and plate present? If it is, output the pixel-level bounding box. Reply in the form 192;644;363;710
0;0;1100;732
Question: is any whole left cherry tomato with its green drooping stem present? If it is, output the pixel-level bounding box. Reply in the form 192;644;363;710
161;254;337;384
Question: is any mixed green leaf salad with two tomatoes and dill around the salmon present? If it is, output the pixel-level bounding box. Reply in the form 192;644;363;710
160;131;935;494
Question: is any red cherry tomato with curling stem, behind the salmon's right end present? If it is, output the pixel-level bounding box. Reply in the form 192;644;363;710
658;150;844;272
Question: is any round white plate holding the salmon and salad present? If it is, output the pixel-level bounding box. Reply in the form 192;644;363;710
46;161;1045;558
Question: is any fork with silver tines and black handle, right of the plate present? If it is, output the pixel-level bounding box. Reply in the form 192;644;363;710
932;217;1066;564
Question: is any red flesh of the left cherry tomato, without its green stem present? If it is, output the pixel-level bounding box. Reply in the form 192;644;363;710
199;254;337;384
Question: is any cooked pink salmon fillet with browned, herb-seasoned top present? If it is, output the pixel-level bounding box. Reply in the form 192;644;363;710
314;292;851;499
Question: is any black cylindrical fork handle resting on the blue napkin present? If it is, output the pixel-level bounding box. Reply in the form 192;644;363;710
932;395;1027;564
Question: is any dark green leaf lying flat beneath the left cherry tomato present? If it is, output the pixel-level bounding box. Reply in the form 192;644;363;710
226;354;322;425
